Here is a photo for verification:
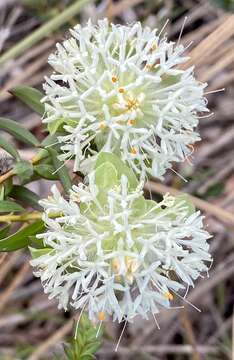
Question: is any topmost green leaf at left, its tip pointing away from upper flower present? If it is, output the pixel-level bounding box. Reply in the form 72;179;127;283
9;85;45;115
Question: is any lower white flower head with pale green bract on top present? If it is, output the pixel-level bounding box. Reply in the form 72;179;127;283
32;158;211;321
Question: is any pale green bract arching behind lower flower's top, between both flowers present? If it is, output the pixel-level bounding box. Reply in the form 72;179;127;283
95;152;138;189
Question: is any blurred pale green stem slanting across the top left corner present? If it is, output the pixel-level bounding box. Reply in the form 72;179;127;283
0;0;91;65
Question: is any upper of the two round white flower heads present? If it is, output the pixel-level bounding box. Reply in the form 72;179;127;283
43;20;208;179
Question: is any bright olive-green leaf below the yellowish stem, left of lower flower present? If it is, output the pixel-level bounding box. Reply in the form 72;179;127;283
0;220;45;251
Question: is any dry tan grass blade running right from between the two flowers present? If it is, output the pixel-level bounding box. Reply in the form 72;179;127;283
145;181;234;225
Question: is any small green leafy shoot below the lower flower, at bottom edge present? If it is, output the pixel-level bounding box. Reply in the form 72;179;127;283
64;313;103;360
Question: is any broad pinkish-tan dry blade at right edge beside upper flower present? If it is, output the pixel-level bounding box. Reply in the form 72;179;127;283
182;15;234;68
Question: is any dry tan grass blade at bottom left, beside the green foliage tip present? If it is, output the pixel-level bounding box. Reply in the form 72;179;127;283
28;319;73;360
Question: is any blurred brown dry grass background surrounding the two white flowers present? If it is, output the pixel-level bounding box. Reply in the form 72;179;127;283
0;0;234;360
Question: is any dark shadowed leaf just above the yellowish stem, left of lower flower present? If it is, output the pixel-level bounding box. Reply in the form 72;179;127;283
9;185;41;210
